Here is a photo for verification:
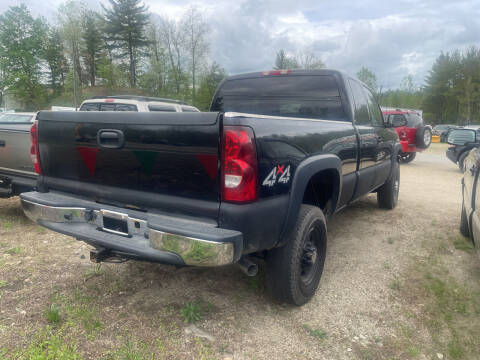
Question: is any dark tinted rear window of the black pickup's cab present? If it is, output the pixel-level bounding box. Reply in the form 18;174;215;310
211;75;348;121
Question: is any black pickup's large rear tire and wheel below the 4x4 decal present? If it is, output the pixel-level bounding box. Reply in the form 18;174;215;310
266;205;327;306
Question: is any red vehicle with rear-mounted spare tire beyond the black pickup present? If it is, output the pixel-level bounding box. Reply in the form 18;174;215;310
382;108;432;163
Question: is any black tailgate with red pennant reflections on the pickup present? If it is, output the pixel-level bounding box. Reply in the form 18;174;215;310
37;111;221;218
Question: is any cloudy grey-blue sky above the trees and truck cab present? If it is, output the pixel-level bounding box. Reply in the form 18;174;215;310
0;0;480;88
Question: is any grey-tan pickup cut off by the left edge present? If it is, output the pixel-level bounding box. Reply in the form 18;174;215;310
0;112;37;197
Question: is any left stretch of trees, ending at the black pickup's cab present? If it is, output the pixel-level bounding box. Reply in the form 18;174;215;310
0;0;226;110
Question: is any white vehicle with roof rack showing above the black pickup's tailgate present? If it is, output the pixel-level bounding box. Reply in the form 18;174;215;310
80;95;200;112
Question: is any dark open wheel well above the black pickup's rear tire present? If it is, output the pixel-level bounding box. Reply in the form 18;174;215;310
302;169;339;215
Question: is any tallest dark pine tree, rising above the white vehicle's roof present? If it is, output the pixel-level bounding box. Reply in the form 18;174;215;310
102;0;149;87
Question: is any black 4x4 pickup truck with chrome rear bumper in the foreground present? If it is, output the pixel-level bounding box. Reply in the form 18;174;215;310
21;70;404;305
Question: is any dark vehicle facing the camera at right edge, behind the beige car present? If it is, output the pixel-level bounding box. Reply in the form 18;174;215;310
446;127;480;171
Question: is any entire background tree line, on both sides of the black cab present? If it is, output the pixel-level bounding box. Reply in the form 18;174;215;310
0;0;480;124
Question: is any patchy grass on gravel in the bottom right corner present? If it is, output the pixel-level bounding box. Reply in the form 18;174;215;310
394;256;480;360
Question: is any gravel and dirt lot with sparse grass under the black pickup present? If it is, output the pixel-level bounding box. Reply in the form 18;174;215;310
0;144;480;359
